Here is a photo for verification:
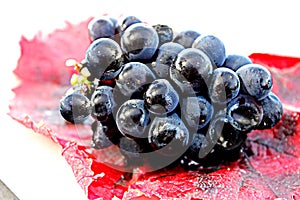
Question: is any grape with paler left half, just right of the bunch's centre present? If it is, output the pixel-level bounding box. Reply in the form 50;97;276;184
182;96;214;131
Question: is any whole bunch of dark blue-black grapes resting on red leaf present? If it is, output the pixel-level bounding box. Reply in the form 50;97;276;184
60;16;283;170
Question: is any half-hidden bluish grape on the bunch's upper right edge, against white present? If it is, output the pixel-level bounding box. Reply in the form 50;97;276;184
223;54;252;71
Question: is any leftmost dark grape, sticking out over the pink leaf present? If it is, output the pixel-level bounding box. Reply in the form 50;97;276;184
59;93;92;123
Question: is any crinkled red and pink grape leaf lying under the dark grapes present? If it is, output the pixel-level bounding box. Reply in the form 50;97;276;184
9;19;300;199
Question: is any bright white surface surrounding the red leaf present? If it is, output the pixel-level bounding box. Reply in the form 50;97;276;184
0;0;300;200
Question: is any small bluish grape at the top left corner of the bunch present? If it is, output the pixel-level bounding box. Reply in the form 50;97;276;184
88;16;115;41
